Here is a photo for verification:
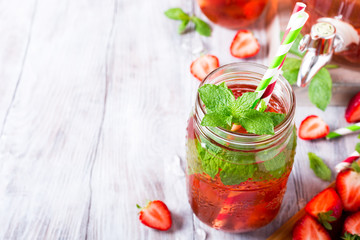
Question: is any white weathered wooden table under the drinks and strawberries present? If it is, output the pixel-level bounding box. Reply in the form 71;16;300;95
0;0;357;240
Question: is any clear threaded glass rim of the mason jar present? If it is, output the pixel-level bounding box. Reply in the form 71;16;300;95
196;62;296;145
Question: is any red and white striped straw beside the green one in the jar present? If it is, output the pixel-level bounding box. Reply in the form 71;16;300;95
257;2;306;109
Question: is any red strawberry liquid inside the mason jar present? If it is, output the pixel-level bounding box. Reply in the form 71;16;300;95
187;85;296;232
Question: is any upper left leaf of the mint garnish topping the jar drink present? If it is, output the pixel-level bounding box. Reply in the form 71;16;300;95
198;82;235;113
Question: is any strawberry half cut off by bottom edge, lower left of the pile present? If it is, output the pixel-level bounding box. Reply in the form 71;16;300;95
293;214;331;240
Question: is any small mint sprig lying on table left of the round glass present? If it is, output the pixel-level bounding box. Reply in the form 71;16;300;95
165;8;211;37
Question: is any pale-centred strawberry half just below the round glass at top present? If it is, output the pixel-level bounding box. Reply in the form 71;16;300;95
230;30;260;58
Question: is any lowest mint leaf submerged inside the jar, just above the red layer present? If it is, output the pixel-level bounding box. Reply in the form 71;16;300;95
220;162;257;185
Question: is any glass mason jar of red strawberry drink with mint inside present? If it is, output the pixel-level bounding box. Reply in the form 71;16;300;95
186;63;296;232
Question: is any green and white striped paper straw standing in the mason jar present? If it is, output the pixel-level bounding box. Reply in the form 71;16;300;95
253;8;309;107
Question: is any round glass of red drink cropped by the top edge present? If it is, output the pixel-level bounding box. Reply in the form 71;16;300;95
197;0;277;29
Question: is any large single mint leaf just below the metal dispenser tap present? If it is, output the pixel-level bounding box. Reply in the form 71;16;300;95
309;68;332;111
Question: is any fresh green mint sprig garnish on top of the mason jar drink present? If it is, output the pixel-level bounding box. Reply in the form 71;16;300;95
199;82;285;135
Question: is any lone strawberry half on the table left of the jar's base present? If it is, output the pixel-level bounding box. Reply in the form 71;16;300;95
137;200;172;231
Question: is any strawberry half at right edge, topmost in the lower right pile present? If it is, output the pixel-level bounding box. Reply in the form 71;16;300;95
336;169;360;212
